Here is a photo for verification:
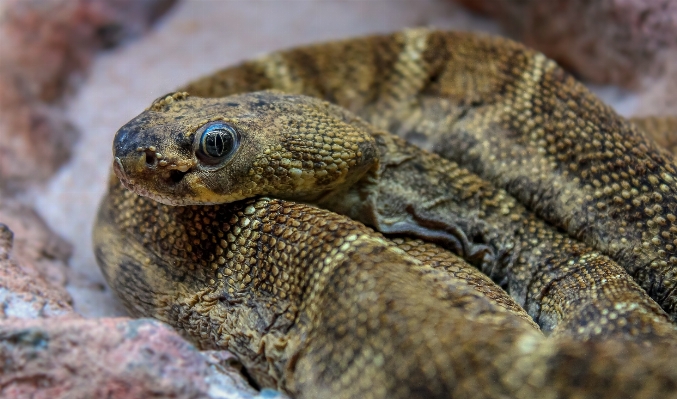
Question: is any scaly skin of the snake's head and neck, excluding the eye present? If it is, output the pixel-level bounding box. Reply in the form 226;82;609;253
113;92;677;342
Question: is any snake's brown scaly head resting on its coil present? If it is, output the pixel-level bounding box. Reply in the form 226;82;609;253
113;91;378;205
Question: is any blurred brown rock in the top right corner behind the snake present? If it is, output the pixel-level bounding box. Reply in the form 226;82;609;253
457;0;677;87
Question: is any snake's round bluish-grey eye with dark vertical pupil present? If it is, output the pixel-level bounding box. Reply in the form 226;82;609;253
195;122;240;165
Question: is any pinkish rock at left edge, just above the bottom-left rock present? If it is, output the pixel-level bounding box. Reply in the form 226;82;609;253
0;200;73;319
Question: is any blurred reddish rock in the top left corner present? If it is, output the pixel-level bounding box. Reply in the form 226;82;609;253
0;0;174;188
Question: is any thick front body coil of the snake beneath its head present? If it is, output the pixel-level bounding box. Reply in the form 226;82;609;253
94;178;677;399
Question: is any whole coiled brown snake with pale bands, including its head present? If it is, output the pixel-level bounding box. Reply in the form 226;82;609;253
94;29;675;397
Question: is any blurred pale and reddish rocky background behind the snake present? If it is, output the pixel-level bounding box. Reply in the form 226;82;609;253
0;0;677;317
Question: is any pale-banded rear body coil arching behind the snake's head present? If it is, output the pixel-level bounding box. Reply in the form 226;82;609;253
173;29;677;320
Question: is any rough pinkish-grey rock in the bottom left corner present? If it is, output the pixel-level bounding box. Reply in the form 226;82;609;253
0;317;282;399
